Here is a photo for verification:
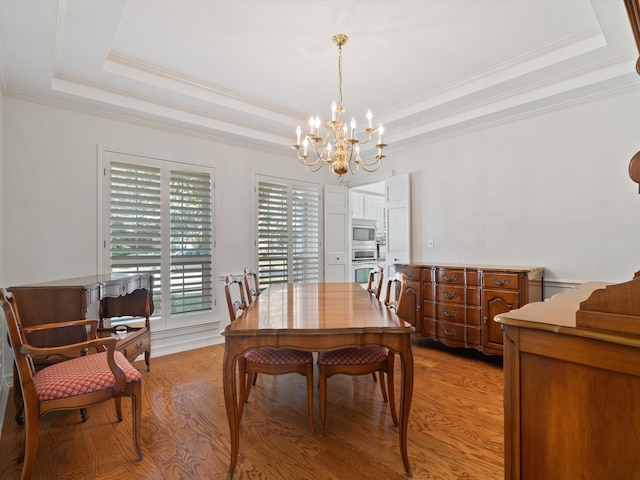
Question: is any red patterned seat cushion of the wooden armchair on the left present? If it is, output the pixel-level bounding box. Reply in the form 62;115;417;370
33;352;141;400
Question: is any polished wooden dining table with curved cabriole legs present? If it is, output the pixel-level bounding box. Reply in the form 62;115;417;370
222;283;414;480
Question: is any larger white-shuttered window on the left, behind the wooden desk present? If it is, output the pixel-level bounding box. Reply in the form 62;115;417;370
103;152;214;325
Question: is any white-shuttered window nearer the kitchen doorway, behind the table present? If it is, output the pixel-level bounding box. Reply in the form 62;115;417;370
254;176;322;285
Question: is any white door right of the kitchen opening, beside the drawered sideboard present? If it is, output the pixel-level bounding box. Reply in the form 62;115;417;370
385;173;411;276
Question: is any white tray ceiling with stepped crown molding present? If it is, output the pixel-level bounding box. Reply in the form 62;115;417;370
0;0;640;154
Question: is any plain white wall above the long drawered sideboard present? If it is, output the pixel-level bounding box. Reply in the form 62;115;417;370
388;85;640;283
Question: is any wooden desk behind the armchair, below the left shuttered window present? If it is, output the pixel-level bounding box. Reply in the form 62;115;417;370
8;274;153;423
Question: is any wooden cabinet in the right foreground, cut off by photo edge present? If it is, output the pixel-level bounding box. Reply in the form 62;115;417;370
496;278;640;480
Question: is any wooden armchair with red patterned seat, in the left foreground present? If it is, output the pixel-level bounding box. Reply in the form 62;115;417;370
0;289;142;480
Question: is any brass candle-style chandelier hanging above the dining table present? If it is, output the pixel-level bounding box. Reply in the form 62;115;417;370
291;33;387;182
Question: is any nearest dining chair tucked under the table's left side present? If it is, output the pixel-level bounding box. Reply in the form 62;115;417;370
224;275;315;434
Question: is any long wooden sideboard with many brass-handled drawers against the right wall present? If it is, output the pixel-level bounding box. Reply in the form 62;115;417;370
395;263;544;354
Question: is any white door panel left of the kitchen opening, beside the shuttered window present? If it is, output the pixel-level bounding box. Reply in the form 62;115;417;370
324;185;350;282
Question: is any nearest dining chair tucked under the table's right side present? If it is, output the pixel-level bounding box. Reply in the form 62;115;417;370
318;272;407;431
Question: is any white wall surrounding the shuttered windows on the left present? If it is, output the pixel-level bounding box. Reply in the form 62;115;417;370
2;97;336;362
